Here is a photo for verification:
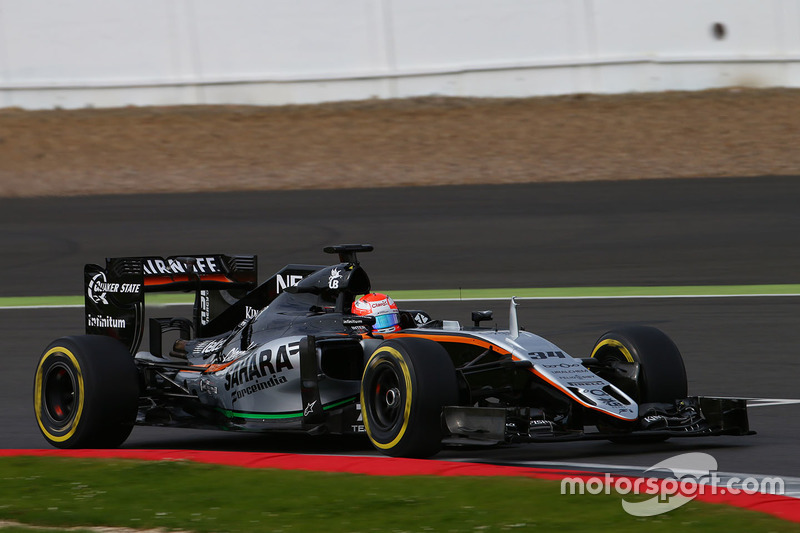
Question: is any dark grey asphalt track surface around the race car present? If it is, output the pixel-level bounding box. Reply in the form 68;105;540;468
0;177;800;477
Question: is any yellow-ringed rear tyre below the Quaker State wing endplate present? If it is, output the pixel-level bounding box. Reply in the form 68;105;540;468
33;335;139;448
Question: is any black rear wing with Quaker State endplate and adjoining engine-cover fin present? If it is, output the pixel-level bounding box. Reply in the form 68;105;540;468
84;254;322;353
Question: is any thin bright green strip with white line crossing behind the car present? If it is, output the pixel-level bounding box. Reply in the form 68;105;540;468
0;284;800;308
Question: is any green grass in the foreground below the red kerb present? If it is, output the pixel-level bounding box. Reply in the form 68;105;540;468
0;457;797;533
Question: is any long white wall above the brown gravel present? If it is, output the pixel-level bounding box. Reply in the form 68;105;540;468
0;0;800;108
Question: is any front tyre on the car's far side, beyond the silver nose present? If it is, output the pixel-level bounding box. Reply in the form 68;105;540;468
592;326;688;443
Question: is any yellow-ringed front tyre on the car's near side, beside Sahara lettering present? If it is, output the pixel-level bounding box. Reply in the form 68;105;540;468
361;338;458;457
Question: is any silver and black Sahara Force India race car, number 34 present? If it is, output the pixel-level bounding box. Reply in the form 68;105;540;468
34;245;752;457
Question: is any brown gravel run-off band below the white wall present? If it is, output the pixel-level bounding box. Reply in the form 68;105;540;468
0;89;800;197
